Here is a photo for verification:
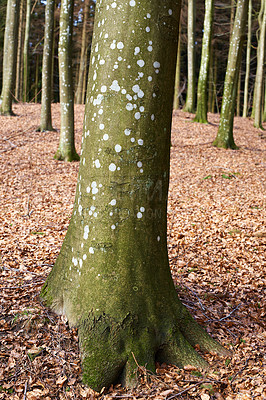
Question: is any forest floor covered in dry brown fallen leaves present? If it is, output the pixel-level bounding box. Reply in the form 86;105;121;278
0;104;266;400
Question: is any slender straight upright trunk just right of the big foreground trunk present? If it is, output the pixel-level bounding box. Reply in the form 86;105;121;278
185;0;196;113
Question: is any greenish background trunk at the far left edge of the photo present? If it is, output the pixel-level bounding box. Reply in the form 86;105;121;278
0;0;20;115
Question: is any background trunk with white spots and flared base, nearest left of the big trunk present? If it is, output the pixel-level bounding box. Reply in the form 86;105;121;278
54;0;79;161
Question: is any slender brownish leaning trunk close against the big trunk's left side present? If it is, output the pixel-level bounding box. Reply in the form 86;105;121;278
76;0;89;104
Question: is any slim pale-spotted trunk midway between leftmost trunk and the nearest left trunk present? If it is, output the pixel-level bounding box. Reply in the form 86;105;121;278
40;0;55;132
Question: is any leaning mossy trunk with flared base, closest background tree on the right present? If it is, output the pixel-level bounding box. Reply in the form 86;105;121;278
213;0;248;149
